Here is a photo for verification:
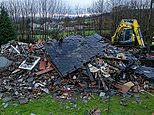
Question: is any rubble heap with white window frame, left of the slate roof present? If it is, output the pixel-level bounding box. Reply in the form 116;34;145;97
0;41;58;104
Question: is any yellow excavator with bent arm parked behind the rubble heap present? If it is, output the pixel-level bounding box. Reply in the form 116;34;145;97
112;19;145;48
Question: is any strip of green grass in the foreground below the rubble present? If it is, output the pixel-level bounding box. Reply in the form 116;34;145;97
0;94;154;115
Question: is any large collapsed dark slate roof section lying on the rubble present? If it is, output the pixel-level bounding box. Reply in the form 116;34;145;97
45;34;103;76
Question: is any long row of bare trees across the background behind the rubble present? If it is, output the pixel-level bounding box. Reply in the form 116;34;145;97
1;0;154;43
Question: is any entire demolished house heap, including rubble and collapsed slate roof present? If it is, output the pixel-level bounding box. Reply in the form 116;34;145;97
0;34;154;104
